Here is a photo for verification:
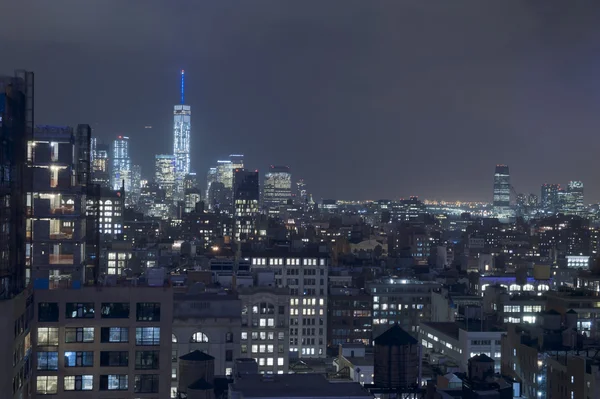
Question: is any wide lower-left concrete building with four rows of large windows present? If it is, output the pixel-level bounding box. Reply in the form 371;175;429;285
32;278;173;399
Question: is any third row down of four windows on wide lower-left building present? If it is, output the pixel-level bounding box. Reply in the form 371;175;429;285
37;351;159;371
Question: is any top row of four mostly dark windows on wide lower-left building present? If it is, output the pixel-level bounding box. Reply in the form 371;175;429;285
38;302;160;322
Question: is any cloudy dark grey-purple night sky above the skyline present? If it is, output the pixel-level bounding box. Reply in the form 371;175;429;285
0;0;600;202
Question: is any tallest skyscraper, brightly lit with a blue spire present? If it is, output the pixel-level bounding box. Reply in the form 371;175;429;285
173;69;192;195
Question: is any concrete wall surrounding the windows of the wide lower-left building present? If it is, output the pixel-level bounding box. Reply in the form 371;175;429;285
32;286;173;399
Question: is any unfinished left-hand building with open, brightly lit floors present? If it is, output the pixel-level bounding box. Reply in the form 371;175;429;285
27;125;93;289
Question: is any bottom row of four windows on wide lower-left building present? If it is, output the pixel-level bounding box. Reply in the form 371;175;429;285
36;374;159;395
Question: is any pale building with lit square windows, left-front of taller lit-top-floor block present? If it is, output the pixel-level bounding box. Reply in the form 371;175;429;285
238;287;290;374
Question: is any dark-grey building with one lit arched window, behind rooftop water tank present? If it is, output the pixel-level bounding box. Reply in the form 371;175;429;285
172;286;242;387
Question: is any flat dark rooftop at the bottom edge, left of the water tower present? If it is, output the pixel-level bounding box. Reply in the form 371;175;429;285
229;374;373;399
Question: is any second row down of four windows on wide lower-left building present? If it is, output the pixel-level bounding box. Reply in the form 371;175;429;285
37;327;160;346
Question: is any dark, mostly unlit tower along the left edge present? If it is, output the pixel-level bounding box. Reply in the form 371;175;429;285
0;71;35;399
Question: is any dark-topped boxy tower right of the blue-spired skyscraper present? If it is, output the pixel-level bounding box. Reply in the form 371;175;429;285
233;169;259;241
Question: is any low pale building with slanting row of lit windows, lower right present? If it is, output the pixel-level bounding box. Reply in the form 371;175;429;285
419;320;503;372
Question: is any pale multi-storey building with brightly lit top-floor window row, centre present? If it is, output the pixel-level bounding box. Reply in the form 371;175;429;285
250;252;329;358
